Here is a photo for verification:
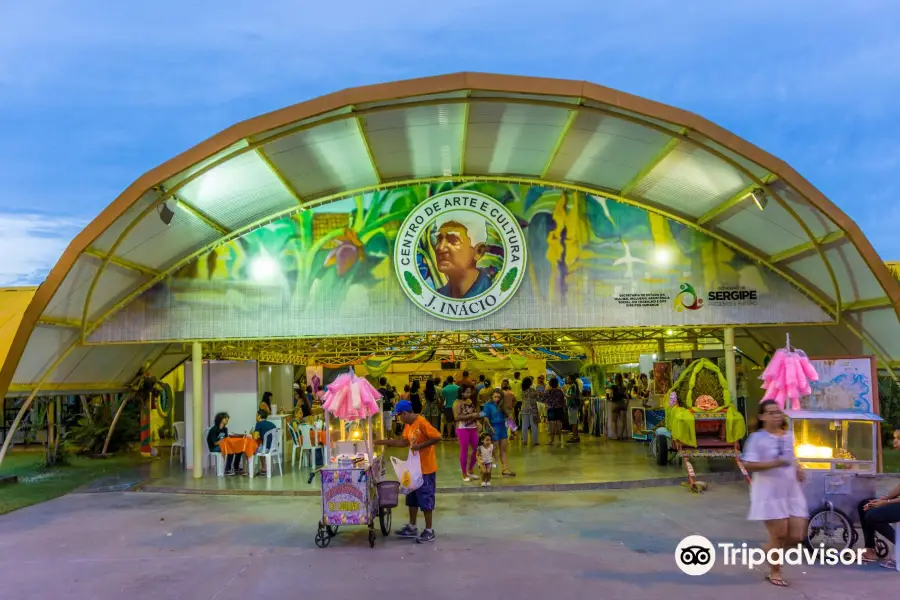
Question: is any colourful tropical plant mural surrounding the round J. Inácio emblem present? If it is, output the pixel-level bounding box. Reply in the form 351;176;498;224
91;182;829;341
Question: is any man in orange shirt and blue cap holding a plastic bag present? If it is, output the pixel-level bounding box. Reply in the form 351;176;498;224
375;400;441;544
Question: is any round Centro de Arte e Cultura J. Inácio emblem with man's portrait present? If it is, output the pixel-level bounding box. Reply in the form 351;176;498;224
394;190;527;321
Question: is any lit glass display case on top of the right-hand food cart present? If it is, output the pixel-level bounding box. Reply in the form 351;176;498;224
785;410;882;473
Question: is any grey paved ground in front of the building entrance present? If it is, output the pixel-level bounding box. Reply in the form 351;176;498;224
0;484;900;600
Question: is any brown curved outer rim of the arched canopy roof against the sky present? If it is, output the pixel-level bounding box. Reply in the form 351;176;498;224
0;72;900;396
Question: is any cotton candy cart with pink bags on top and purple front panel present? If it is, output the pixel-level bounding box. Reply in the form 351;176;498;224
309;371;399;548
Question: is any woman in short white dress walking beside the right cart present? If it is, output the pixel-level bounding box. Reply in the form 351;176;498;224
742;400;809;587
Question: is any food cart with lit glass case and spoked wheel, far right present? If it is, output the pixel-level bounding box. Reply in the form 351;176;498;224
785;410;888;557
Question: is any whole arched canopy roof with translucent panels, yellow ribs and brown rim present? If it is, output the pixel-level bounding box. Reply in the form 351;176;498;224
7;73;900;390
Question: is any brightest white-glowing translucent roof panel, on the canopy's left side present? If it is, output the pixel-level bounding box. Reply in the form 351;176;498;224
178;152;297;229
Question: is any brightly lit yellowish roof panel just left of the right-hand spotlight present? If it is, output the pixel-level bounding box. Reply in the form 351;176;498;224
632;143;750;217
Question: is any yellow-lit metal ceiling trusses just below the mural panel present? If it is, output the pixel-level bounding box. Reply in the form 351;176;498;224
188;328;722;365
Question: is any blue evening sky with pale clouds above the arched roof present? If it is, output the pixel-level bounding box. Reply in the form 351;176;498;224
0;0;900;285
